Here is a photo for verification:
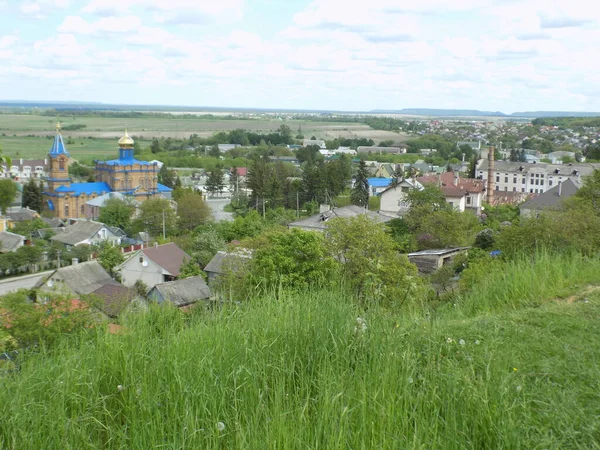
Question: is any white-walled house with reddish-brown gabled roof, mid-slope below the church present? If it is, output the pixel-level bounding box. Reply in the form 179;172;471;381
115;242;190;289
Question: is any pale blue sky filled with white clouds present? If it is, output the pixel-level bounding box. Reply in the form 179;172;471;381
0;0;600;113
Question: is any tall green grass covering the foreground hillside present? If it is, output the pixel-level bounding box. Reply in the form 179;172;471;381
0;255;600;449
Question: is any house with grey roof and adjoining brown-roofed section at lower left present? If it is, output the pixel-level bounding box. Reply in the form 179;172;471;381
36;261;139;317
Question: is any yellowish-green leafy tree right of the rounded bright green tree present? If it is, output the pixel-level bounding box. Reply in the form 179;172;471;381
326;214;422;305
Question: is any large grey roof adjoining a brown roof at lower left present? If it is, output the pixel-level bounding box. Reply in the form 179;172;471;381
36;261;118;295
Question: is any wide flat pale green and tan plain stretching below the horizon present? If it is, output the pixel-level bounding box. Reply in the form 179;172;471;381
0;114;407;142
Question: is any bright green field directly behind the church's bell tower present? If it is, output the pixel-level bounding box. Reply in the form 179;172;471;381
0;136;149;162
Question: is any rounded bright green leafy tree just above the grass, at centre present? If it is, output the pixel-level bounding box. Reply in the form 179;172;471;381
250;228;335;289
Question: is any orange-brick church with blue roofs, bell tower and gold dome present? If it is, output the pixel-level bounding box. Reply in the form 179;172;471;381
44;124;171;219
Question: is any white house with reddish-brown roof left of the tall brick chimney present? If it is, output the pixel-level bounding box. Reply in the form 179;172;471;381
417;172;485;214
